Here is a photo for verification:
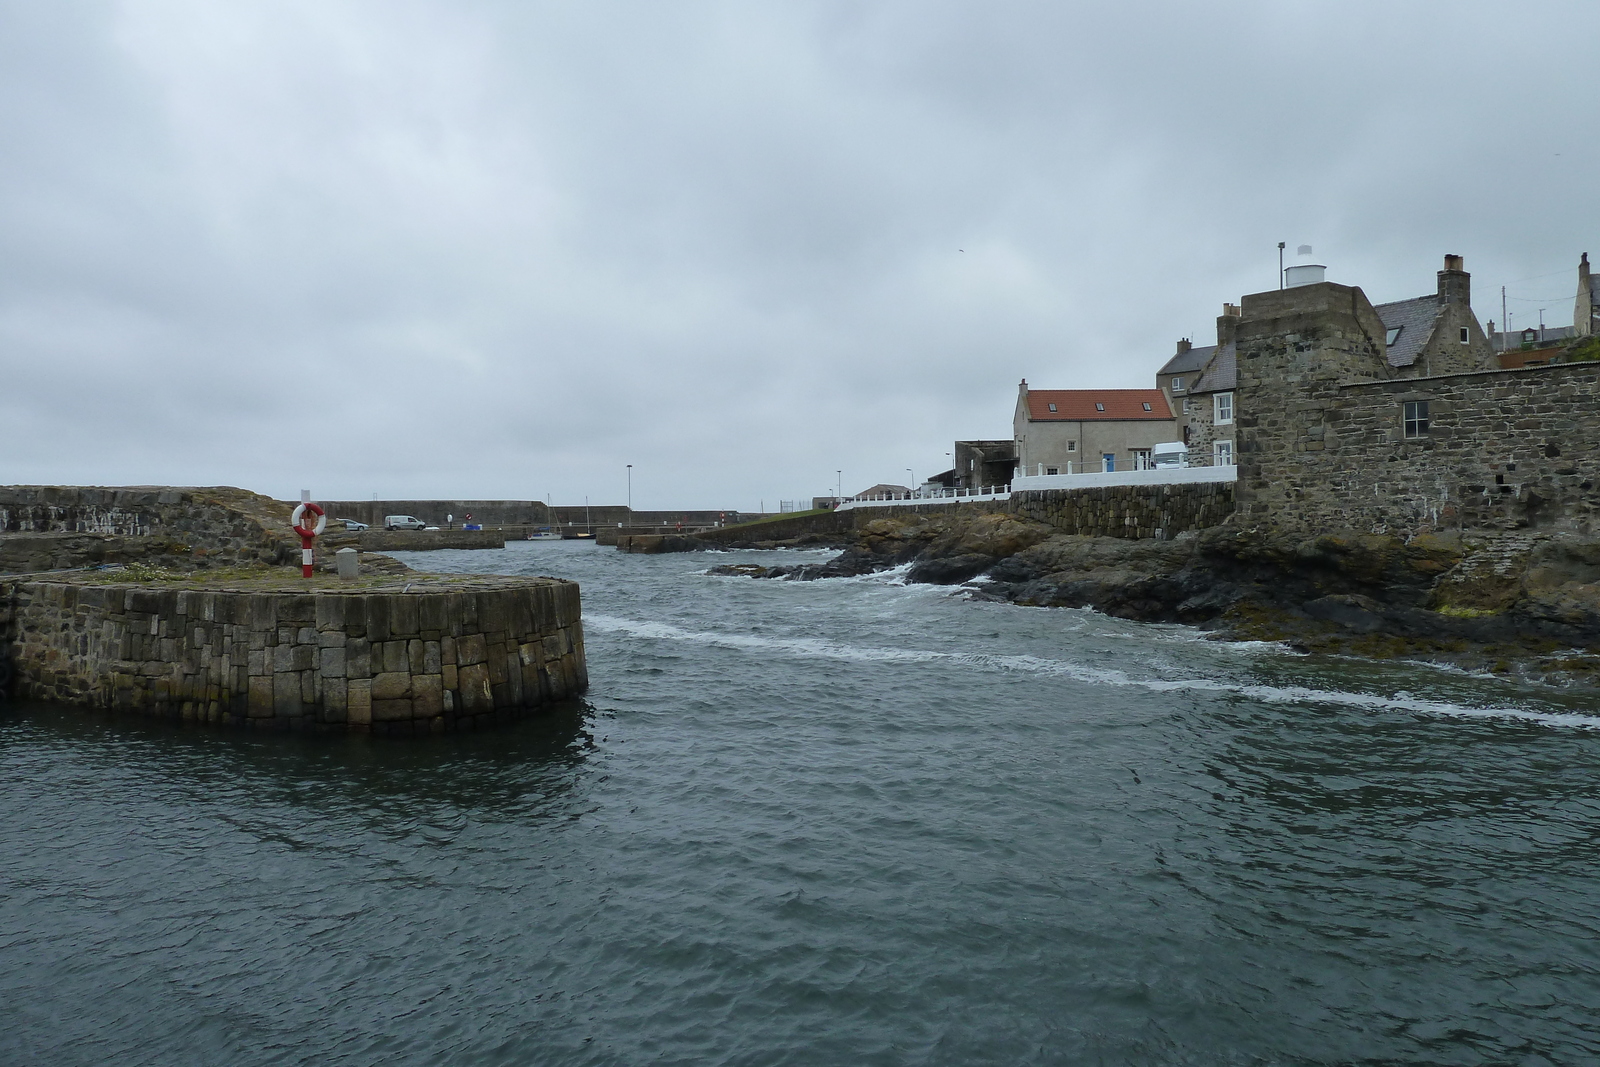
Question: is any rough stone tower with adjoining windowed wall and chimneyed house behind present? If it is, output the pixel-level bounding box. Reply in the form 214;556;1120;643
1235;268;1600;536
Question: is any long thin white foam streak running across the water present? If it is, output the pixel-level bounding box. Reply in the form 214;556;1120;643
584;614;1600;729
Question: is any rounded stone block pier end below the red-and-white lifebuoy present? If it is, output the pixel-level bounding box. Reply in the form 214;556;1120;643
0;577;589;736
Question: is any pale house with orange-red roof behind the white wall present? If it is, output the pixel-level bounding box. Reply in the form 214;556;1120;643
1011;378;1178;475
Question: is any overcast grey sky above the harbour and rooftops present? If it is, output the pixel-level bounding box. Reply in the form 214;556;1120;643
0;0;1600;510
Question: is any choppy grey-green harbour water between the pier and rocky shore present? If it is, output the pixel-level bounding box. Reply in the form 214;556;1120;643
0;542;1600;1065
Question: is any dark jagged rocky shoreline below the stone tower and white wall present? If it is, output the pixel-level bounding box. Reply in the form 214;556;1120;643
712;514;1600;686
